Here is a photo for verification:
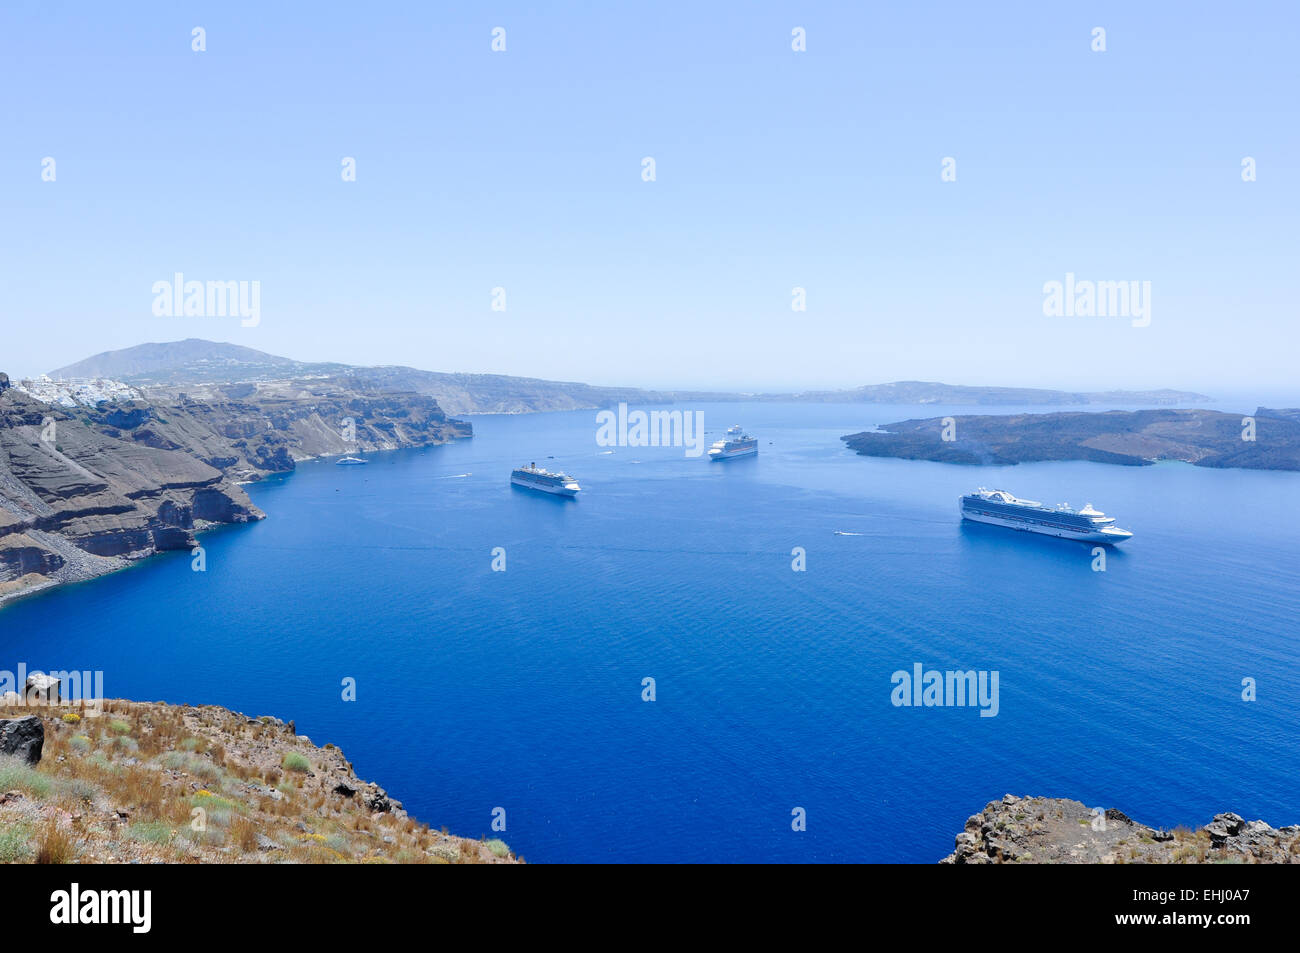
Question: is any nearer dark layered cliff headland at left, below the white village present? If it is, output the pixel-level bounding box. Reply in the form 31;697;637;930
0;389;263;601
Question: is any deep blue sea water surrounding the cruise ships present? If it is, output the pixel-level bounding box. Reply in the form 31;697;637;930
0;403;1300;863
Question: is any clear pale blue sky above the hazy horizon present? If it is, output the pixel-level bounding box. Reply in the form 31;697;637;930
0;0;1300;393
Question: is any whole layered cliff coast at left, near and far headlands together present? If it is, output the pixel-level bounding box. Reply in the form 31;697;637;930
0;378;471;602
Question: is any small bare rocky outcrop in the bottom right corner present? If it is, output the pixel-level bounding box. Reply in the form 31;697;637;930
940;794;1300;863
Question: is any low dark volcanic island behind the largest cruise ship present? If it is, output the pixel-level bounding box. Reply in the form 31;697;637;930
841;408;1300;469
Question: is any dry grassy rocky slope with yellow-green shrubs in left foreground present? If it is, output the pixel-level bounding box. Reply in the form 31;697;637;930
0;699;521;863
